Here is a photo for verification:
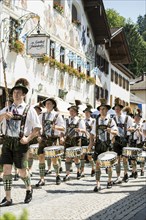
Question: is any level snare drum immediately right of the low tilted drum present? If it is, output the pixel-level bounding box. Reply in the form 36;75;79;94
122;147;142;157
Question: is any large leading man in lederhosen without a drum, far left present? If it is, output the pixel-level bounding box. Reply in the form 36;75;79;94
0;78;41;207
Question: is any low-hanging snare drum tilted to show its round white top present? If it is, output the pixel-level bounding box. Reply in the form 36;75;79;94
98;151;117;168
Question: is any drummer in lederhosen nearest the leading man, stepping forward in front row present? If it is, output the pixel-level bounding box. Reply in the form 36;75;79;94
36;98;64;187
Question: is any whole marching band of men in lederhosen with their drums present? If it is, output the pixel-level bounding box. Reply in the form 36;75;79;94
0;78;146;207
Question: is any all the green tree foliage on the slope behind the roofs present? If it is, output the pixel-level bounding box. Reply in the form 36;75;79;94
106;9;146;76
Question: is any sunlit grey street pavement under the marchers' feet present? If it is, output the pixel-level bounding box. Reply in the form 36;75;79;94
0;160;146;220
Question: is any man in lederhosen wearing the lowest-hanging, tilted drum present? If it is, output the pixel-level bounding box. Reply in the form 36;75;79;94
89;99;117;192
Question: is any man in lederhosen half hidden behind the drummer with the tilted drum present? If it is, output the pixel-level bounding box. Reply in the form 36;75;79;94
81;106;95;177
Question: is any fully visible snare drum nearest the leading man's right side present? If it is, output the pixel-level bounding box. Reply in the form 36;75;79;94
44;146;64;158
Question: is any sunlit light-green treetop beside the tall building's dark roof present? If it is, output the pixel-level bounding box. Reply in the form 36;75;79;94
106;9;126;28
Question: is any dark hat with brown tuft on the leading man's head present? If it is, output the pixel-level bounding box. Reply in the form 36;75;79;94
11;78;29;94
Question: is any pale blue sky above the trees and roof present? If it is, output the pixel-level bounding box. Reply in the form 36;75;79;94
103;0;146;23
